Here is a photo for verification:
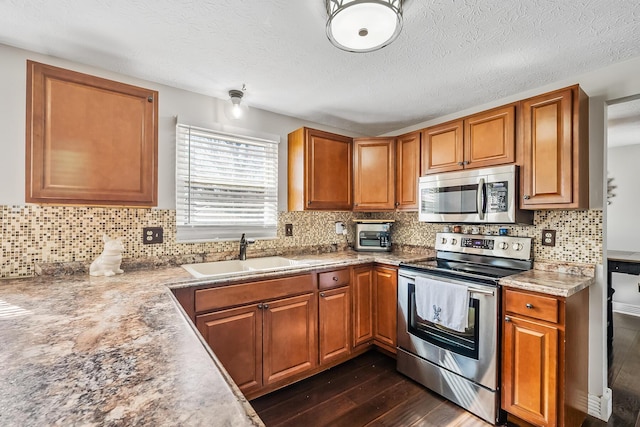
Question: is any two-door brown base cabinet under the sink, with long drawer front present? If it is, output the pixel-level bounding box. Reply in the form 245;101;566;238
195;275;318;395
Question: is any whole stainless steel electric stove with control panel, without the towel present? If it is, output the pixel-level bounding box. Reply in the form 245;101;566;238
397;233;532;424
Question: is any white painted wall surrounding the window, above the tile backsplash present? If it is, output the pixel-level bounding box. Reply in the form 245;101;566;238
0;44;362;210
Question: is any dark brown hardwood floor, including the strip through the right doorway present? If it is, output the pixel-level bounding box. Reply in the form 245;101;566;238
251;313;640;427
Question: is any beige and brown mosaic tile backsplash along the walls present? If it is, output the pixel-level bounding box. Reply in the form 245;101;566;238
0;205;602;278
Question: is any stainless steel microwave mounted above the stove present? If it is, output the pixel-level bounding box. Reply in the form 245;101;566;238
418;165;533;224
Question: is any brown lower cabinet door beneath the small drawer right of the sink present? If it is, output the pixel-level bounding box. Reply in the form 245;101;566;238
318;286;351;364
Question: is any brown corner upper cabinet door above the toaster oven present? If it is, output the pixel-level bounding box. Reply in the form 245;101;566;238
353;138;395;211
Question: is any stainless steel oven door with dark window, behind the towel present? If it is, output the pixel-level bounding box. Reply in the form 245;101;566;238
398;269;500;390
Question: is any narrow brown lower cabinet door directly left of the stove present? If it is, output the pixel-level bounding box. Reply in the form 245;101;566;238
373;267;398;353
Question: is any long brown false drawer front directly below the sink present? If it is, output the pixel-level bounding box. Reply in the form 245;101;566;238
195;274;315;313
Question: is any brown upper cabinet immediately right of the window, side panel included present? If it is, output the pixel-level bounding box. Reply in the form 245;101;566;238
288;127;353;211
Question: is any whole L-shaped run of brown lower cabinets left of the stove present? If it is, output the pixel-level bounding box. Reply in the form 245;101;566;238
190;264;397;399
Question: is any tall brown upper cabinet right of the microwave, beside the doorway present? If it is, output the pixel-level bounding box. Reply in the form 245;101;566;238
520;85;589;209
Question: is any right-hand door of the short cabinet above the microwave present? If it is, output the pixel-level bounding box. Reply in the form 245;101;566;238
464;105;516;169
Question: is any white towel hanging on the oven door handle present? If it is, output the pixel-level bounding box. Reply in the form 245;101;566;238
415;277;469;332
